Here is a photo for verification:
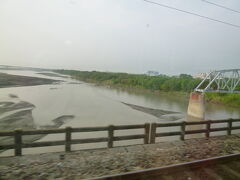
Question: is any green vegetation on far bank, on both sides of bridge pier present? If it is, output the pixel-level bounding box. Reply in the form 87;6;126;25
55;70;240;106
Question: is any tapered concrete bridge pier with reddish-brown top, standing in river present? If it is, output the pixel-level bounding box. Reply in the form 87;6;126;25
187;92;205;120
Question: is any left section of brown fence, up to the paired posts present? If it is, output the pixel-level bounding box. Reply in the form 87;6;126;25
0;123;150;156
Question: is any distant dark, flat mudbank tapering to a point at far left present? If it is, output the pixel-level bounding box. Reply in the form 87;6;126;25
0;73;60;88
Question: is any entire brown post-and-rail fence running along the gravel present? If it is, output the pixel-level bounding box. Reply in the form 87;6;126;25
0;119;240;156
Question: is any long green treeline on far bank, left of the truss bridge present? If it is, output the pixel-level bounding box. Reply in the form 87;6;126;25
55;70;201;92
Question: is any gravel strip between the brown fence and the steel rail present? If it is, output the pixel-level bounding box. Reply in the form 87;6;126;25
0;134;240;180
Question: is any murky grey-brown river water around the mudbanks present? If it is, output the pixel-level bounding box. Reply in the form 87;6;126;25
0;70;240;155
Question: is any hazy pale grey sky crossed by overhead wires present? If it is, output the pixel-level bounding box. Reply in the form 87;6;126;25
0;0;240;74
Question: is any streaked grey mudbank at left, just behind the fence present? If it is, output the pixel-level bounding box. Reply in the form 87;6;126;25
0;94;74;146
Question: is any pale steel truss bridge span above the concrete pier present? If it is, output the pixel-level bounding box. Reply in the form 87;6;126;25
195;69;240;93
